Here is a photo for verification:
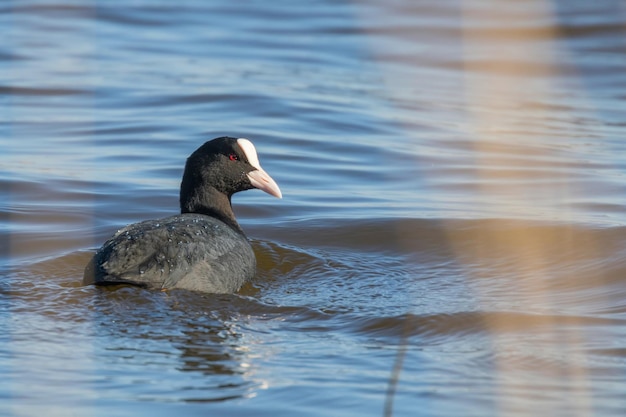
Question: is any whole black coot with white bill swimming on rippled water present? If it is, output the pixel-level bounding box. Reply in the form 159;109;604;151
83;137;282;293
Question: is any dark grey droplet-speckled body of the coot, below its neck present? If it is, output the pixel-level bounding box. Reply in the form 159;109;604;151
85;214;256;292
